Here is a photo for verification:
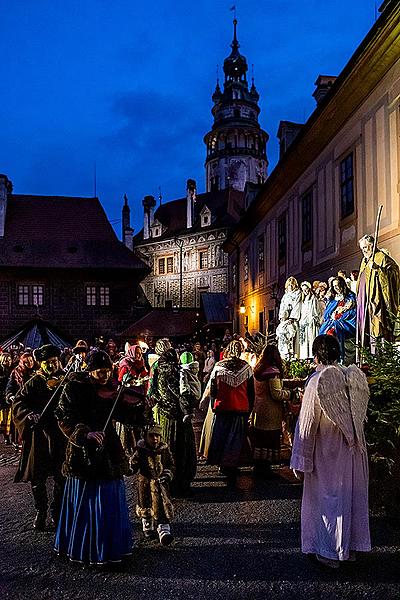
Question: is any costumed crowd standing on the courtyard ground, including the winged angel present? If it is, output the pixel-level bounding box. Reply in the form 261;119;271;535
0;332;370;568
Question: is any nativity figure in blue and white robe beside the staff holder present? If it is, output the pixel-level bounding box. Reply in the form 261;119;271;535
319;277;357;362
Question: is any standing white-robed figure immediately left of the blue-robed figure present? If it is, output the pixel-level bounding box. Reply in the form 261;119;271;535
299;281;321;359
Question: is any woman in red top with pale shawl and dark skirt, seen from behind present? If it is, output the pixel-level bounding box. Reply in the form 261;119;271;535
200;340;254;485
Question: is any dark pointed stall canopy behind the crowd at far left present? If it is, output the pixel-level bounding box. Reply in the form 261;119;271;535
0;318;71;350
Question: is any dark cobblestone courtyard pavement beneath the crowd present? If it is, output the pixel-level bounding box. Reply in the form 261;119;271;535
0;445;400;600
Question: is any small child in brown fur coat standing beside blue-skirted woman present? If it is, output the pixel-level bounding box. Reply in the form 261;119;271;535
131;425;175;546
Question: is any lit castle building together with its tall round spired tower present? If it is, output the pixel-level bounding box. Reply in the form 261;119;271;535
132;19;268;308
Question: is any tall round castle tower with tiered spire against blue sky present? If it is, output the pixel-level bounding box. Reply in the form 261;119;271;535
204;19;269;192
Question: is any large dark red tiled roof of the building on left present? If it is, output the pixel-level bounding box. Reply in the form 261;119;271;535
0;194;146;269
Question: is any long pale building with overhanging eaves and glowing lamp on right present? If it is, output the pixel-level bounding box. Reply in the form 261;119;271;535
225;0;400;332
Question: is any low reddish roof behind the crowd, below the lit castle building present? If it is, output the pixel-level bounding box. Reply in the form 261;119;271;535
121;308;199;338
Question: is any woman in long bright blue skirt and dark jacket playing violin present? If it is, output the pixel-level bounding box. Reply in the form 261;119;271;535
55;350;132;565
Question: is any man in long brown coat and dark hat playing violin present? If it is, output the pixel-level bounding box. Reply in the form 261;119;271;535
12;344;66;530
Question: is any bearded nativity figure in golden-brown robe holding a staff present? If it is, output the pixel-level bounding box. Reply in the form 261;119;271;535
357;235;400;350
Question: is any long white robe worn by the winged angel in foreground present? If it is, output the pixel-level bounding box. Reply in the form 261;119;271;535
290;369;371;561
